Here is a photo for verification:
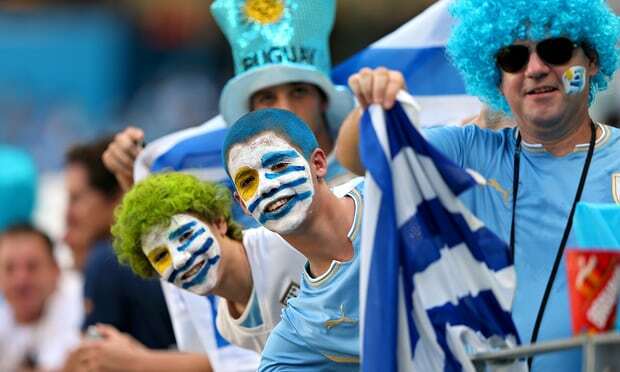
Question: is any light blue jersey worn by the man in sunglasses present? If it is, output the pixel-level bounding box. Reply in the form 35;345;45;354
425;125;620;371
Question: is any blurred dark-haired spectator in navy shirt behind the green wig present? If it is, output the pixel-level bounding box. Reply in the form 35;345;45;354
65;138;175;349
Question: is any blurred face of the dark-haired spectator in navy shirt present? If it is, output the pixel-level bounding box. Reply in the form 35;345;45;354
65;164;116;249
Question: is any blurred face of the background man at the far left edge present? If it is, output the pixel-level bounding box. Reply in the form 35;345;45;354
0;233;59;323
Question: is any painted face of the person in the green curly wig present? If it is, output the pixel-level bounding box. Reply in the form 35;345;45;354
142;213;220;295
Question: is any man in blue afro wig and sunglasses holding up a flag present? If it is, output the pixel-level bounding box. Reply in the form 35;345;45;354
336;0;620;371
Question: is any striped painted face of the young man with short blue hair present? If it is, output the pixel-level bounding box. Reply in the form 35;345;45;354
228;132;314;234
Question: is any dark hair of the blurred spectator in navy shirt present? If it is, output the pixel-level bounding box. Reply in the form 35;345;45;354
65;136;120;197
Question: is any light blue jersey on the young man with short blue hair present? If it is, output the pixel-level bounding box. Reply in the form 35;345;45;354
259;183;363;371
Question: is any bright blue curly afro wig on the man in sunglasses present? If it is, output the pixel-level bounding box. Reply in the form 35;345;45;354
448;0;620;113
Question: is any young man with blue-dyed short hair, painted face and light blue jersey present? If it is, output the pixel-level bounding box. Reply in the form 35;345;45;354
222;109;362;371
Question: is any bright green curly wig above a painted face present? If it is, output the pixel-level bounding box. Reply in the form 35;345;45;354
112;172;242;278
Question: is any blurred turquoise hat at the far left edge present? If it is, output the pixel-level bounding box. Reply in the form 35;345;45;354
0;145;37;232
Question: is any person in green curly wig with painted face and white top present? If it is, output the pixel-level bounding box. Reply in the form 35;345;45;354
112;173;304;360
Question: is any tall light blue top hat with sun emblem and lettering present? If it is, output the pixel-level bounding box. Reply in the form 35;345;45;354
211;0;354;137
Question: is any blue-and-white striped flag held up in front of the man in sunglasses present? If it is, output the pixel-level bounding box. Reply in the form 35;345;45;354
360;92;522;371
